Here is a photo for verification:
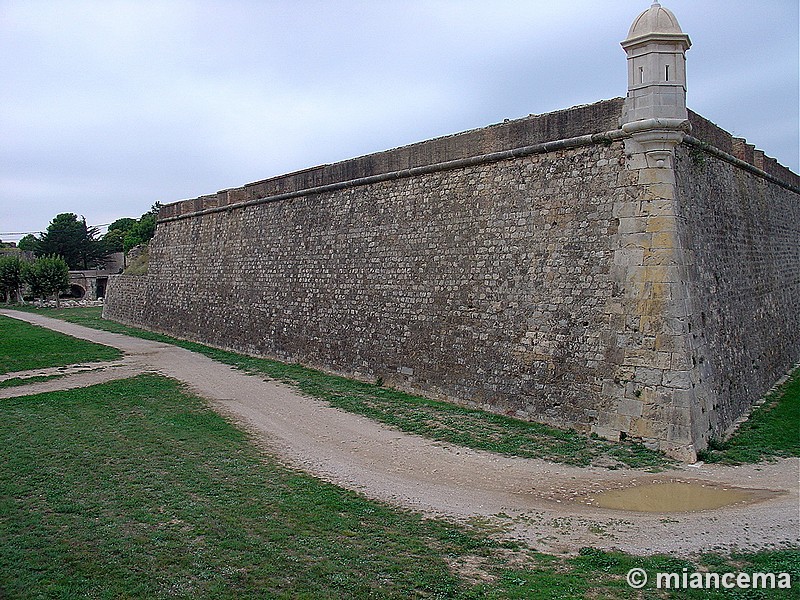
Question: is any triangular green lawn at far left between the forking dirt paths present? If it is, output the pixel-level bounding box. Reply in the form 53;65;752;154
0;316;122;374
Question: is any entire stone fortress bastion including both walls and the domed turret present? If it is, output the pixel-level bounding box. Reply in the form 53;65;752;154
104;2;800;461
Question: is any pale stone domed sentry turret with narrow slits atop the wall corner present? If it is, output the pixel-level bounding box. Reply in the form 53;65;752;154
620;2;691;168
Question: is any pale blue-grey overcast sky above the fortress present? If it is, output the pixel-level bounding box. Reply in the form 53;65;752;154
0;0;800;241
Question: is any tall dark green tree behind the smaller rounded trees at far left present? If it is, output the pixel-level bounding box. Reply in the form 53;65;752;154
36;213;108;269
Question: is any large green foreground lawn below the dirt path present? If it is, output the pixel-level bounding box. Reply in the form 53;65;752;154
0;375;800;599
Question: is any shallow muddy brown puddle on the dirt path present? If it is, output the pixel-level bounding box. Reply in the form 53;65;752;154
588;482;763;512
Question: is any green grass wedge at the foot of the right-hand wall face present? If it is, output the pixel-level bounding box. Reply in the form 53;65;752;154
700;369;800;464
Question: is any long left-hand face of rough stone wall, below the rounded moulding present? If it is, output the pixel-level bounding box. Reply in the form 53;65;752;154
106;138;624;430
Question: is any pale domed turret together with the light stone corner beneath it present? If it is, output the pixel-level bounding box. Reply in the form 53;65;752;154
592;2;708;461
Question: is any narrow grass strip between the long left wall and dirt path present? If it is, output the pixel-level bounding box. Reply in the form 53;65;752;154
12;308;673;470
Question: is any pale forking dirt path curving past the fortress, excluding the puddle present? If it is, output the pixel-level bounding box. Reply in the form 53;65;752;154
0;310;800;554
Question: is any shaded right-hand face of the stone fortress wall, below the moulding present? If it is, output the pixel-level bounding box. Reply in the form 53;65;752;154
675;146;800;437
